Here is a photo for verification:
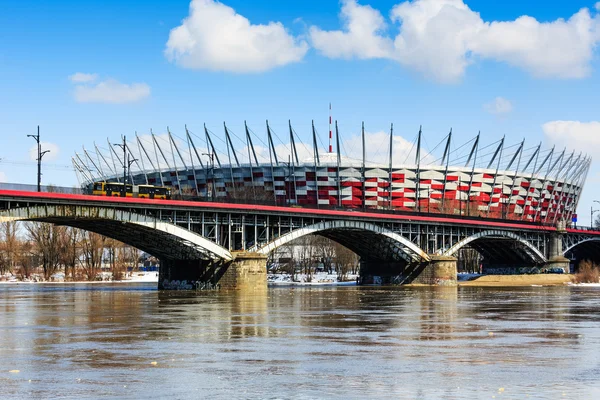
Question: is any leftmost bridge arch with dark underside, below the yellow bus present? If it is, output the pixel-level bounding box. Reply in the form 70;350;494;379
0;205;233;261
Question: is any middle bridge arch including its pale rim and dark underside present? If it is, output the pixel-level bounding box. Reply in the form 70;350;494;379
251;220;430;262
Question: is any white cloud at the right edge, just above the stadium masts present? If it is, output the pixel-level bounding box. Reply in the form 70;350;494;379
542;121;600;153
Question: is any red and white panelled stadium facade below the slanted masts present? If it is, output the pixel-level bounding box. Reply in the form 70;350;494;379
76;126;591;223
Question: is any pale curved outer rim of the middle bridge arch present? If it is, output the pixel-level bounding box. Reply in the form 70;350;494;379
250;221;430;262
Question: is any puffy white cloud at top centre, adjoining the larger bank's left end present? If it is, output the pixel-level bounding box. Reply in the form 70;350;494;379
310;0;393;59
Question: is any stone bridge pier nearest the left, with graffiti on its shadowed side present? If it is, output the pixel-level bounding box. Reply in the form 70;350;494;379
158;252;267;290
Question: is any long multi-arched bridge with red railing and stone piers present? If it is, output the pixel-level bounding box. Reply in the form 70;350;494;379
0;190;600;289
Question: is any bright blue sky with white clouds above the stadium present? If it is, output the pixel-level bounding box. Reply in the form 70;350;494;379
0;0;600;223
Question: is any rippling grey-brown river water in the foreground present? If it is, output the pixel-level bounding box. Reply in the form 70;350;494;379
0;284;600;400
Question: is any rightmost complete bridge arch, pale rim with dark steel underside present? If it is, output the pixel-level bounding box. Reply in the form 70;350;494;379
442;230;547;264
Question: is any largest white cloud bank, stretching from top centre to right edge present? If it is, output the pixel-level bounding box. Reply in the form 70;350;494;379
310;0;600;83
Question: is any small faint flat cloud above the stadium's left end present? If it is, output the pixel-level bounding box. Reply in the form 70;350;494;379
74;79;150;104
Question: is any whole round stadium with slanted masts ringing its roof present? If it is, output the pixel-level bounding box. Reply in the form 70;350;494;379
72;121;591;224
